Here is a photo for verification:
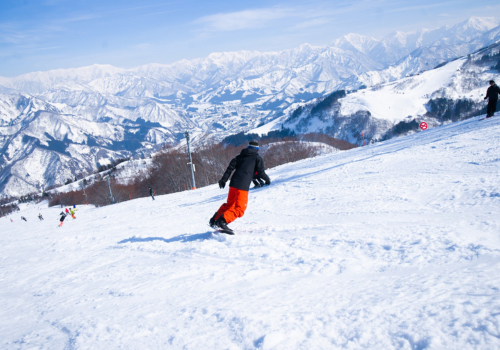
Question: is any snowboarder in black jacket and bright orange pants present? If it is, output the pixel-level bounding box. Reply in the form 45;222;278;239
210;141;271;234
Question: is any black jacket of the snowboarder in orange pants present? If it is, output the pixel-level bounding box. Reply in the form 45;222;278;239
221;148;270;191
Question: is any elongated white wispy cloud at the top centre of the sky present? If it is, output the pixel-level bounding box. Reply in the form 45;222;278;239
195;7;299;32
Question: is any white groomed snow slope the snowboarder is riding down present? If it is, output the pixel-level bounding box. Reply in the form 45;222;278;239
0;117;500;349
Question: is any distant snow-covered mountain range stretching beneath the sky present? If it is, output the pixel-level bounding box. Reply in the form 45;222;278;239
0;17;500;195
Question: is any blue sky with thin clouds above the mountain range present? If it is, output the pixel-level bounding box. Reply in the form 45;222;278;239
0;0;500;76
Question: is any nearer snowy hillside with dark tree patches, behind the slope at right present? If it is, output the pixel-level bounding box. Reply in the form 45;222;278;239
276;39;500;145
